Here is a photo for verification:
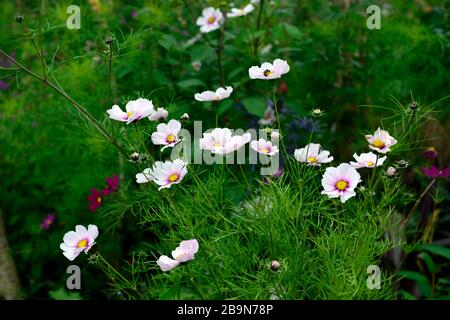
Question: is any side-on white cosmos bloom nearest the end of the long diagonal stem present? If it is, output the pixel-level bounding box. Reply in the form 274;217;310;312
106;98;154;124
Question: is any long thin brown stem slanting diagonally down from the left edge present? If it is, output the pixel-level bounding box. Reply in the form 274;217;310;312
0;49;128;157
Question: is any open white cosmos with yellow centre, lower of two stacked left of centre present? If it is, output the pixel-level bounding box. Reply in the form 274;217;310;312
152;159;187;190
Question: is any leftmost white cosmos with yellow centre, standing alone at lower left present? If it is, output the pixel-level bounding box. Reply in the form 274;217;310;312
59;224;98;261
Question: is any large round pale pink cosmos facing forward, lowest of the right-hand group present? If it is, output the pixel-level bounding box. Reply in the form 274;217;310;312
322;163;361;203
